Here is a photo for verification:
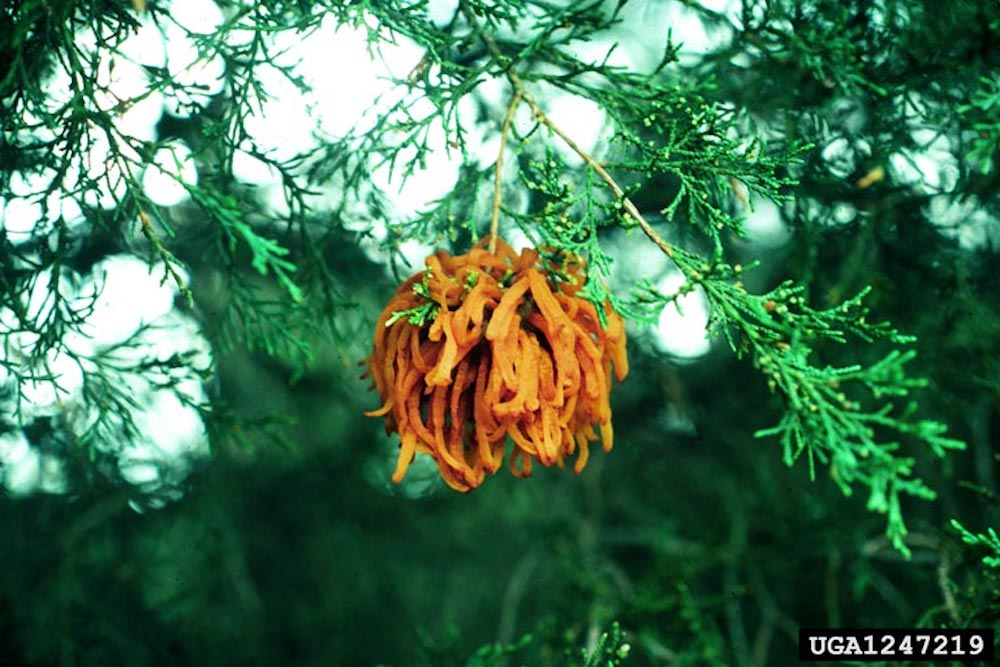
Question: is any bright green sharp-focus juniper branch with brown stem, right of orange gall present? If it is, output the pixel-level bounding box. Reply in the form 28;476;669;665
460;1;964;555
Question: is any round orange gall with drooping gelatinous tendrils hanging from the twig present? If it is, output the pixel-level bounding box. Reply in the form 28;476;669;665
365;240;628;491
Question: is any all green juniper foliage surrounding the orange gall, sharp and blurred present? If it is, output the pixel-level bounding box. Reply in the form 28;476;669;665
0;0;1000;667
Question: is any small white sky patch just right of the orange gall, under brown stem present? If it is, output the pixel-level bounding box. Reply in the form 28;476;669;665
652;271;712;360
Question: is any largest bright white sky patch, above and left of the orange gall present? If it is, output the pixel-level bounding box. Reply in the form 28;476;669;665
233;11;446;230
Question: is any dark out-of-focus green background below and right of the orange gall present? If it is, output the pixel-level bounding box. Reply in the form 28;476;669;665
0;0;1000;667
